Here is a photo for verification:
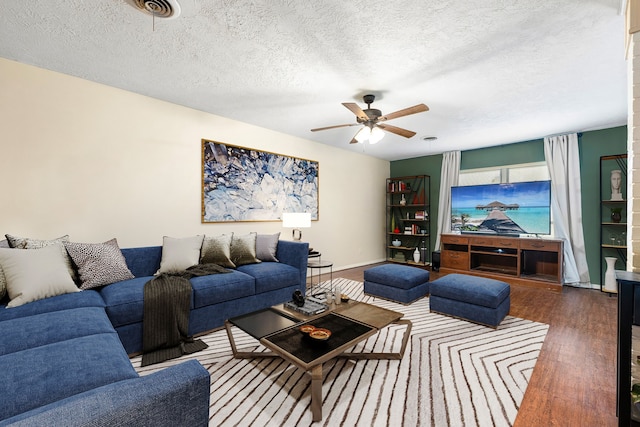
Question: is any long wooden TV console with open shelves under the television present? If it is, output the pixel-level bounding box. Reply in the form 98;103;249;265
440;234;562;291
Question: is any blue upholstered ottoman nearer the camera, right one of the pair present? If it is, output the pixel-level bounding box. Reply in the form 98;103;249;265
429;274;511;328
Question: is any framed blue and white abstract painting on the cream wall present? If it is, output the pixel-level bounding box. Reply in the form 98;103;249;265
200;138;320;224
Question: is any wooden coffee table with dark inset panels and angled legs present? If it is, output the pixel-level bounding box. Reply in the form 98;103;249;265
225;301;412;421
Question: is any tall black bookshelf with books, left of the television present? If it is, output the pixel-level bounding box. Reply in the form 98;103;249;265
385;175;431;267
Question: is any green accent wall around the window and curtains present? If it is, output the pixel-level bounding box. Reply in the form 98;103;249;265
390;126;627;284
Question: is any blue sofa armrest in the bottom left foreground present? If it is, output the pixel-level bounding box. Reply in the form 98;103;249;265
0;360;210;427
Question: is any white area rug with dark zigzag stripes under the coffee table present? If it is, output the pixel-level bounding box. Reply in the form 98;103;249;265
131;278;548;427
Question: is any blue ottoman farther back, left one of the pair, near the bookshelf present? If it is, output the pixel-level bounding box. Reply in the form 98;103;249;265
364;264;429;304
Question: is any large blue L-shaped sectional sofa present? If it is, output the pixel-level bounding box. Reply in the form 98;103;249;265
0;241;308;426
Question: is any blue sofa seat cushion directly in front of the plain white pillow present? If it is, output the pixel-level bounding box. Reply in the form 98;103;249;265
0;290;105;321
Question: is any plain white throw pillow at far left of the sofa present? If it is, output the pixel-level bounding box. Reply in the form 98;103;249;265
0;245;80;307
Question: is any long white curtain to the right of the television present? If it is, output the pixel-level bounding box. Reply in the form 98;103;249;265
544;133;591;287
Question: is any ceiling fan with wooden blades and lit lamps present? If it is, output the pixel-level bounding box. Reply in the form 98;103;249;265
311;95;429;144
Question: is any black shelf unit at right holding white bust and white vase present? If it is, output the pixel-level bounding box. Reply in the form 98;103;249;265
600;154;627;294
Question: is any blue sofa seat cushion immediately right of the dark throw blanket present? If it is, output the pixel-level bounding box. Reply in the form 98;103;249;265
191;271;256;308
